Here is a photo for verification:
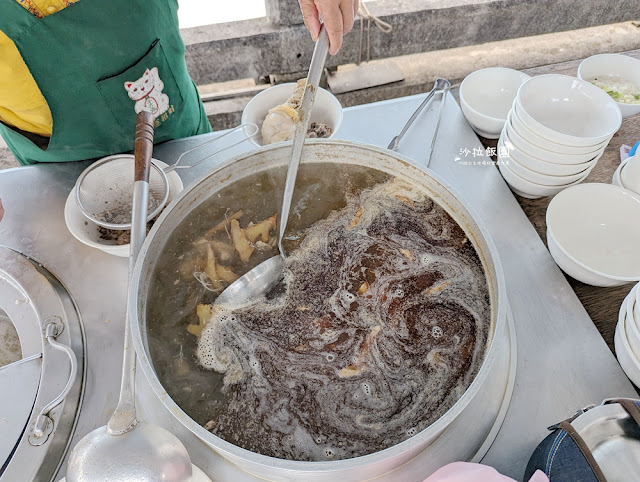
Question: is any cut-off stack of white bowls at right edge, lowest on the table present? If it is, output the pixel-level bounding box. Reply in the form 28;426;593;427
614;283;640;387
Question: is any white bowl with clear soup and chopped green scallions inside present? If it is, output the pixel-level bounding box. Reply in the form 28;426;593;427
578;54;640;117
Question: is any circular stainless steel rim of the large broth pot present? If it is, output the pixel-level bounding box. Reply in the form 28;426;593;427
128;139;507;474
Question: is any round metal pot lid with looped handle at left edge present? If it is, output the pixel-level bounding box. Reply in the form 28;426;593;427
0;247;85;481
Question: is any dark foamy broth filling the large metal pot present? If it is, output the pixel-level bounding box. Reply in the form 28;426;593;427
147;164;491;461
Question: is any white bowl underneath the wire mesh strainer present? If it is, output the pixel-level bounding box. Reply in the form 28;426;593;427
64;156;184;258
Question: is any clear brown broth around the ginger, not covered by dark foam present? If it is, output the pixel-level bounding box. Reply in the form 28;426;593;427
146;163;388;438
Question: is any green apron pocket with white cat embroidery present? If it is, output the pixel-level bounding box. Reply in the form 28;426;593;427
96;39;183;138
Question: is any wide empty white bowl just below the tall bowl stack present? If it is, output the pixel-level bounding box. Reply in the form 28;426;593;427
546;183;640;286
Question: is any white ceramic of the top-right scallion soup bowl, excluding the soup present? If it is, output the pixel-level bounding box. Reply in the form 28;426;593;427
578;54;640;117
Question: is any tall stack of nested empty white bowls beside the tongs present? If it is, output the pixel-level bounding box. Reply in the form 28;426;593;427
497;74;622;199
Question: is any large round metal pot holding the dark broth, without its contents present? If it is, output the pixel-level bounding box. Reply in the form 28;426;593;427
129;140;514;480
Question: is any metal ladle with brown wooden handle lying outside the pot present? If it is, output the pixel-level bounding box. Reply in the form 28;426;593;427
66;112;192;482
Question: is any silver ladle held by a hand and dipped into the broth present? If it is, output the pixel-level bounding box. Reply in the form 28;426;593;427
214;24;329;305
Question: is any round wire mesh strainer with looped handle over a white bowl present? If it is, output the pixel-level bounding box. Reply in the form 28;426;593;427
76;123;259;230
